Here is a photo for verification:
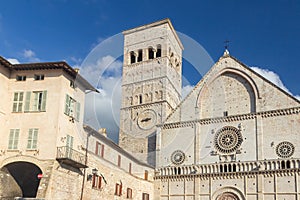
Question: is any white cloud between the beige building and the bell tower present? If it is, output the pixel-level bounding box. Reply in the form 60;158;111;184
80;55;122;142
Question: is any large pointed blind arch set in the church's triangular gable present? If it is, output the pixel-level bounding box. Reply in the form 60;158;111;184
195;68;260;118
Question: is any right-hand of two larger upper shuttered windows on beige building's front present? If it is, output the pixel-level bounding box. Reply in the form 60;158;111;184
24;91;47;112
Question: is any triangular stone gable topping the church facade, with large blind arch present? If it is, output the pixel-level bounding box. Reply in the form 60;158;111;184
166;52;300;123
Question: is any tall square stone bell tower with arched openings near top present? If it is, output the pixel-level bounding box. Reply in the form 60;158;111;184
119;19;183;166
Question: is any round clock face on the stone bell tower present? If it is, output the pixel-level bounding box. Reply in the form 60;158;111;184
137;110;157;130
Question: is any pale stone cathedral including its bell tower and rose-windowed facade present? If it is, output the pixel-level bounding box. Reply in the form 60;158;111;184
119;19;300;200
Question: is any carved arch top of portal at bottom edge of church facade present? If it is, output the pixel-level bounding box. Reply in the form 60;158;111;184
212;187;246;200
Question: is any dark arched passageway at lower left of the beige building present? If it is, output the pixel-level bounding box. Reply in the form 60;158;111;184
1;161;42;198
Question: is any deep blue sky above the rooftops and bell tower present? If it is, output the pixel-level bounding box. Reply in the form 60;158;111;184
0;0;300;141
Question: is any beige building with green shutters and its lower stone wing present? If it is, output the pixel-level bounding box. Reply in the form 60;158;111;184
0;57;154;200
